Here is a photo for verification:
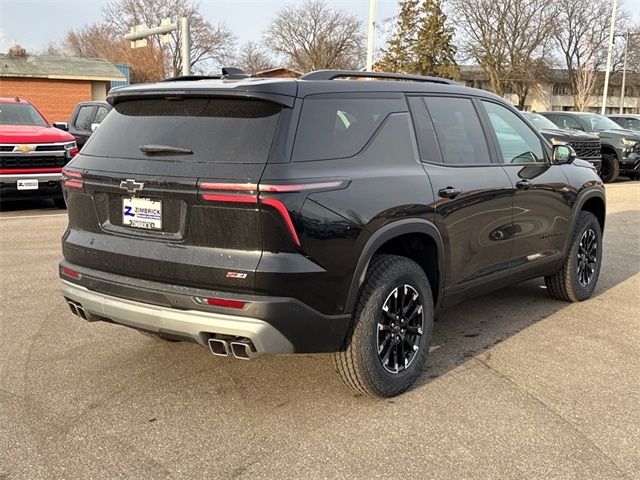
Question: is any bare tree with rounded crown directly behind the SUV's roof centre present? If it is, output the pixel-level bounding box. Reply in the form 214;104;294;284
265;0;365;72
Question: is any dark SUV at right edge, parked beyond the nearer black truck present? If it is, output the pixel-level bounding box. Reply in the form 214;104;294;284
540;112;640;183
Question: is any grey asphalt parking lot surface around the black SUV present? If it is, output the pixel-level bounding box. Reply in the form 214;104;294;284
0;181;640;480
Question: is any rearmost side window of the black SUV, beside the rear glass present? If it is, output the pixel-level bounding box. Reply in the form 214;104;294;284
293;97;407;162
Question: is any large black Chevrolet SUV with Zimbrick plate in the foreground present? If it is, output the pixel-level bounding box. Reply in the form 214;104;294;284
60;69;605;396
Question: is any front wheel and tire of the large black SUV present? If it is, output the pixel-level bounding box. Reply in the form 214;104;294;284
544;212;602;302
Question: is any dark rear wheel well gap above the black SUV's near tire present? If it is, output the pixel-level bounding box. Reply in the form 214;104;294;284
374;233;440;304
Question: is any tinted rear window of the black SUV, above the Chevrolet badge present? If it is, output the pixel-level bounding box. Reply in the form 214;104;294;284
82;98;281;163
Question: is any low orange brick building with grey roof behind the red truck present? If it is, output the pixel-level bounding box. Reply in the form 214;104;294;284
0;49;126;122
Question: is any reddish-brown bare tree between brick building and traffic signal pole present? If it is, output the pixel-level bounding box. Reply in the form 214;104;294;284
63;24;164;83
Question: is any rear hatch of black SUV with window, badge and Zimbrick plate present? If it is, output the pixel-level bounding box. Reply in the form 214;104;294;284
63;97;288;292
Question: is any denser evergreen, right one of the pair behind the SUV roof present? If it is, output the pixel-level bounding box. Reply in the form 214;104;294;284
413;0;458;78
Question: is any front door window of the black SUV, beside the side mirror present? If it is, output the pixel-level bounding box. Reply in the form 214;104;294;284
482;100;546;164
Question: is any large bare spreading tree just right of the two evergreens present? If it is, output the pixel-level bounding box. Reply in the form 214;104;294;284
450;0;556;107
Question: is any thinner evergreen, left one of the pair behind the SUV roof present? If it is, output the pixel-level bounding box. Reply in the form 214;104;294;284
377;0;420;73
